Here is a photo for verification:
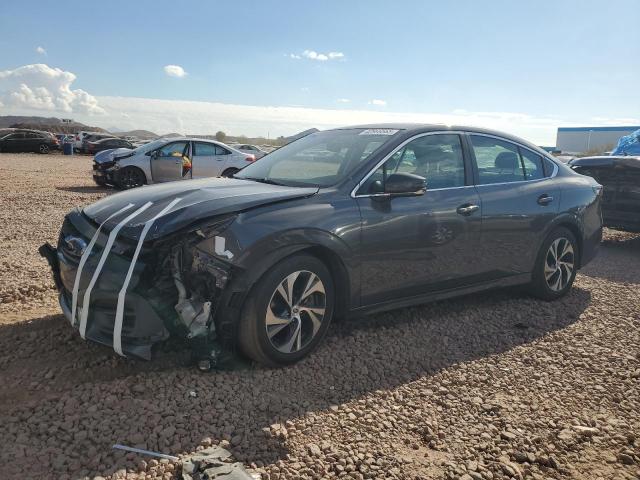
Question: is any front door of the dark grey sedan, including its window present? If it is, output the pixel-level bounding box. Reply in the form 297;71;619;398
356;133;482;306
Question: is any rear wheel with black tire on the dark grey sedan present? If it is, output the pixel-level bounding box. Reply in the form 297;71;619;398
529;227;579;301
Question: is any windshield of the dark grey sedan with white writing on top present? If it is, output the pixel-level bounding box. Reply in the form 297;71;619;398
234;128;398;187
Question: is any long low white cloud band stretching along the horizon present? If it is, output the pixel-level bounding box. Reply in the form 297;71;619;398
75;97;580;145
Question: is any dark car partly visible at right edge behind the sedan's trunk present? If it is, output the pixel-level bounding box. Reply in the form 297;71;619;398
569;156;640;232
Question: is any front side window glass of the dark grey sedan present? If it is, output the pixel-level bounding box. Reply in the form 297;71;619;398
358;134;465;195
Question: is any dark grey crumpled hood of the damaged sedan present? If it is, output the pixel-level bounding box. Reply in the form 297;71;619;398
83;178;318;240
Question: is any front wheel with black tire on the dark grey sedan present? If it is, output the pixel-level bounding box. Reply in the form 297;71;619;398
238;254;335;367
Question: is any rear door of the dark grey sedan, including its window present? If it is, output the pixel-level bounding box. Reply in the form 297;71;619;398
468;134;560;278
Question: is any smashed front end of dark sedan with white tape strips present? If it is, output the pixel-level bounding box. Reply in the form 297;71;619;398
40;210;239;369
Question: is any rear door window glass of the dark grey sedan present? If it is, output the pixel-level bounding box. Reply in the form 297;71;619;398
469;135;525;185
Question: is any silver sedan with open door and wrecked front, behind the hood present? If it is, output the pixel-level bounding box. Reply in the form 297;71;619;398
93;137;255;189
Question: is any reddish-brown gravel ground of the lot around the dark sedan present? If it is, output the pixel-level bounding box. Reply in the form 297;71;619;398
0;154;640;480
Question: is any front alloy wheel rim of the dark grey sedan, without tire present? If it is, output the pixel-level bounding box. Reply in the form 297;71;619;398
265;270;327;354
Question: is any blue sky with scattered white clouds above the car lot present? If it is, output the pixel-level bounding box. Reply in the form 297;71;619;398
0;0;640;145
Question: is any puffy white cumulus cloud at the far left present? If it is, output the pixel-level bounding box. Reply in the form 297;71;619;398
0;63;104;114
